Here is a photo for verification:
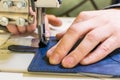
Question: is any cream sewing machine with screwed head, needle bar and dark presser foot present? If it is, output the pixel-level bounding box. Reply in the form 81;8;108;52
0;0;61;47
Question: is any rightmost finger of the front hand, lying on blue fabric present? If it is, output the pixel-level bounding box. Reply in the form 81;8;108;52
80;36;119;65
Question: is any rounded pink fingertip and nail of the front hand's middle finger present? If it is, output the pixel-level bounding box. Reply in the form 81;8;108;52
62;57;75;68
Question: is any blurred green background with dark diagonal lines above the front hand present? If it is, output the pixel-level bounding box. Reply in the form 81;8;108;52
47;0;114;17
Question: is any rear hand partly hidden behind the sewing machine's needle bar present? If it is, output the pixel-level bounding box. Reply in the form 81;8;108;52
7;8;62;36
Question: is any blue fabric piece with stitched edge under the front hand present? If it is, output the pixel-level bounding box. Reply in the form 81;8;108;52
28;37;120;77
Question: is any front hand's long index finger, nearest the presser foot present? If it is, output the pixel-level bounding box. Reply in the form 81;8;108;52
49;17;102;64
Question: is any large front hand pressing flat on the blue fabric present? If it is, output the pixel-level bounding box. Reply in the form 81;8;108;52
47;9;120;68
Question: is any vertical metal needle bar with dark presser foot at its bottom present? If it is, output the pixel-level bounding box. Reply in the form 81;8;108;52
37;8;48;47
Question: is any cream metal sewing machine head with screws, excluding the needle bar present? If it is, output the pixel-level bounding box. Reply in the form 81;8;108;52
0;0;61;26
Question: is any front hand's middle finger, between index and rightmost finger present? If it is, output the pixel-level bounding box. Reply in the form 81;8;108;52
62;24;111;68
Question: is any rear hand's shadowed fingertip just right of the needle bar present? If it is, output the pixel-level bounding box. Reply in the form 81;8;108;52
47;15;62;26
